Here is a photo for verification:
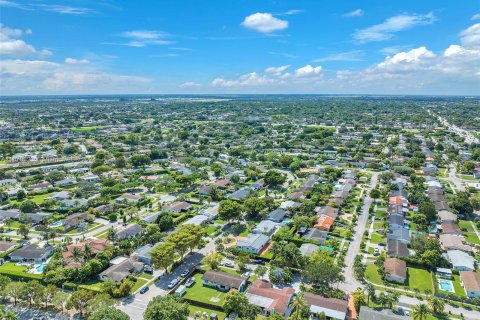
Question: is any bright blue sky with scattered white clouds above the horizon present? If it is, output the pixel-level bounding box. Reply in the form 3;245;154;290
0;0;480;95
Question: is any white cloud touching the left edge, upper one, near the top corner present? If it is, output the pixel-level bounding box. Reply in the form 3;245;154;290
0;24;52;57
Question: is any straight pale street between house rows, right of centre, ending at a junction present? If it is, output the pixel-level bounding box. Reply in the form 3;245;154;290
339;172;379;292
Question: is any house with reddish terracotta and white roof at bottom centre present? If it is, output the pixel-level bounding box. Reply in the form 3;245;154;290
245;280;295;317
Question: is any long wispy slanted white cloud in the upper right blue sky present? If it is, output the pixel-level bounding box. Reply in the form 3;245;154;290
353;12;436;43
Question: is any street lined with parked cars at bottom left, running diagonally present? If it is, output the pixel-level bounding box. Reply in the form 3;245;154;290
117;234;216;319
